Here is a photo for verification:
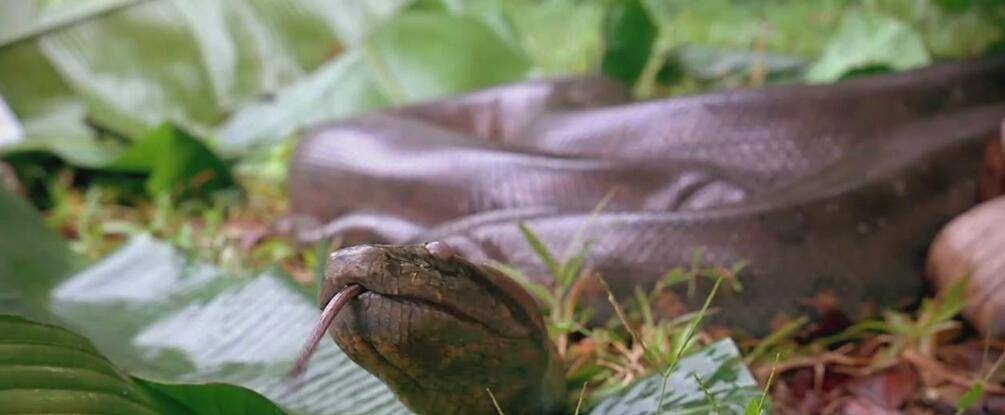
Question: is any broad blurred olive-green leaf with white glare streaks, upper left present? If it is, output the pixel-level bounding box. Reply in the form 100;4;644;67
33;0;336;138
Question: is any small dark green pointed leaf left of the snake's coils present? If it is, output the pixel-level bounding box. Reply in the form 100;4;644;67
105;125;235;196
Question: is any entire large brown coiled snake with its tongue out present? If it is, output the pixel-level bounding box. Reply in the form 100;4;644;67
288;55;1005;414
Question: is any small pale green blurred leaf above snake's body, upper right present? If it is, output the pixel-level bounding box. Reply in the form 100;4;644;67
806;10;932;82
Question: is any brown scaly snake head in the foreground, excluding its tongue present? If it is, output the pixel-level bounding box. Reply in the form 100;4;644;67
321;243;565;414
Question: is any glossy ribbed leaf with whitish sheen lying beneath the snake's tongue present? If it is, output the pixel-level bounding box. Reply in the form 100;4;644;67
40;235;407;415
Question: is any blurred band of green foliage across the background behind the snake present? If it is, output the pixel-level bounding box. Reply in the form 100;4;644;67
0;0;1005;166
